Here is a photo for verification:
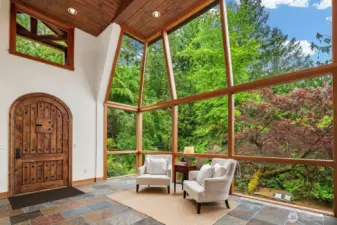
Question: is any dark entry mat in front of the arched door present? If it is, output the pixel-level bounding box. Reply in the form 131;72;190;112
8;187;85;209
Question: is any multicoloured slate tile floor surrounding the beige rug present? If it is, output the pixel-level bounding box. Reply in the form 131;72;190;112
0;177;337;225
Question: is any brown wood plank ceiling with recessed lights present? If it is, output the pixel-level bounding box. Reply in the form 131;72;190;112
12;0;210;38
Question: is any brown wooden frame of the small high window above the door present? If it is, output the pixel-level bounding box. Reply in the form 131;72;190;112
9;2;75;71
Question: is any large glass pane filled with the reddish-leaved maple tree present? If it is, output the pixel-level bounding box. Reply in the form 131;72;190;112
235;76;333;159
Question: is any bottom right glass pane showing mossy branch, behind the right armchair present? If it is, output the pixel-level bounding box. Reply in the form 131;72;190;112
235;161;334;211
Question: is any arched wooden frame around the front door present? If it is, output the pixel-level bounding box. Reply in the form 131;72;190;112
8;93;73;197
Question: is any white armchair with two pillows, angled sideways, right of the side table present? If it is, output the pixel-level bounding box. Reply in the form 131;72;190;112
184;158;240;214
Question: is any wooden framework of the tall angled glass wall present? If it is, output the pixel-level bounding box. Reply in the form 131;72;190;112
104;0;337;217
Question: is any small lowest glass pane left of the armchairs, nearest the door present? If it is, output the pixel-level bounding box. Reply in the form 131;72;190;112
107;154;136;178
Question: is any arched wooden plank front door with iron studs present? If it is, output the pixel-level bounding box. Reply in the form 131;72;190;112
9;93;72;196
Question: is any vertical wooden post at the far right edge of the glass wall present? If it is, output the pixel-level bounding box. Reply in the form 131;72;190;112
332;0;337;217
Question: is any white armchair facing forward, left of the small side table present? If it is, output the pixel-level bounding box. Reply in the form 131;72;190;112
136;155;172;194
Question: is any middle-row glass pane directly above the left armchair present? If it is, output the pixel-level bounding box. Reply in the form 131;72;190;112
143;108;172;151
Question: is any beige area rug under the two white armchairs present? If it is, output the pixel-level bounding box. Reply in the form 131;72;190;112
108;186;237;225
